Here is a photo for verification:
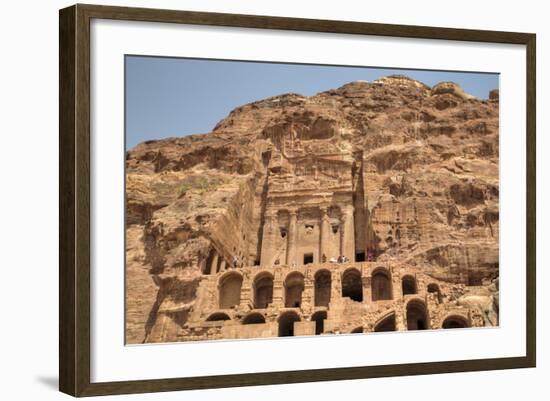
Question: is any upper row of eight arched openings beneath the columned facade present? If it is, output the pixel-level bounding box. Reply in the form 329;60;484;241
219;268;441;309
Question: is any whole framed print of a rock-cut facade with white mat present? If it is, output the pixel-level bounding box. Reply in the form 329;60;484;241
59;5;536;396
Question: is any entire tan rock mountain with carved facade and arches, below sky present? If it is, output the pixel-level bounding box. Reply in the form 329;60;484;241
126;76;499;343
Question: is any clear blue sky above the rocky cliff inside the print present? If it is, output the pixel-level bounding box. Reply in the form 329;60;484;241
126;56;498;149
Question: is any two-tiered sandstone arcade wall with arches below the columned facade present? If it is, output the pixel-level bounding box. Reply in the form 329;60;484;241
169;262;484;340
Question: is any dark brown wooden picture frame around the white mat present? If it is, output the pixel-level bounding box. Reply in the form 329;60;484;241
59;4;536;396
